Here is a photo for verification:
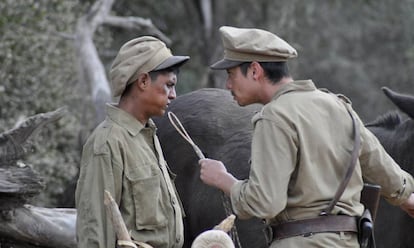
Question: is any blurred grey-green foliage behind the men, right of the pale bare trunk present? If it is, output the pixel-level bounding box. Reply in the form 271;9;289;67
113;0;414;121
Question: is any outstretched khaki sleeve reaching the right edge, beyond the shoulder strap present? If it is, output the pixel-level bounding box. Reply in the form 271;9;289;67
360;125;414;205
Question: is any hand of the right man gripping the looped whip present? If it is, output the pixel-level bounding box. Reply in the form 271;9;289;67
198;158;237;195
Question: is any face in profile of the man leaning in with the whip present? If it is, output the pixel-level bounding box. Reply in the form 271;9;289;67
226;66;256;106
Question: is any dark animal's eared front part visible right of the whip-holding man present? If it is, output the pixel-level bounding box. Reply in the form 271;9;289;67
366;87;414;248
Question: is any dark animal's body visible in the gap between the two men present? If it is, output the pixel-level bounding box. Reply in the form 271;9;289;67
155;89;267;248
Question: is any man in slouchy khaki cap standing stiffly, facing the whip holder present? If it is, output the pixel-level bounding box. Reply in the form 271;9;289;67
76;36;189;248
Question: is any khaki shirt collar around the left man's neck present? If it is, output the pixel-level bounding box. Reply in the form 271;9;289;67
106;103;156;136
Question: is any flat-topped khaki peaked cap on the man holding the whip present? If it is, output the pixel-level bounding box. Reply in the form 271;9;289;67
210;26;298;70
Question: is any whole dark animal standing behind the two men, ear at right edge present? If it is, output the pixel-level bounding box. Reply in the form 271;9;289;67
155;89;414;248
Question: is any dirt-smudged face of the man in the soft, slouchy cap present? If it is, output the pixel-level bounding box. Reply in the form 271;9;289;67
146;72;177;117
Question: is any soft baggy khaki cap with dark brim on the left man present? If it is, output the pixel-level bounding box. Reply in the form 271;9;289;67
109;36;190;97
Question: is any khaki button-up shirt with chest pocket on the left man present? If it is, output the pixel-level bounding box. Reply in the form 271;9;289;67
76;104;184;248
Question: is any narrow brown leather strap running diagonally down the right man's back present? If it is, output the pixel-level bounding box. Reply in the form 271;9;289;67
320;103;361;215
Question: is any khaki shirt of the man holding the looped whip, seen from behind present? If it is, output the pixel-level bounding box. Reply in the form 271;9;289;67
231;80;414;224
